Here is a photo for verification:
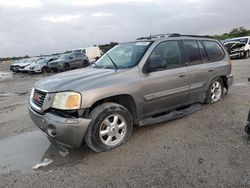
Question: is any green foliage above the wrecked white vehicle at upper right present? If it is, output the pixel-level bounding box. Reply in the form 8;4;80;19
213;27;250;40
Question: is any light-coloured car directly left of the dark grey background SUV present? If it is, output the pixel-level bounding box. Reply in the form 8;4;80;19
25;57;56;73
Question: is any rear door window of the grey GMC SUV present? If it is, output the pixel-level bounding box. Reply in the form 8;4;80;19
183;40;202;65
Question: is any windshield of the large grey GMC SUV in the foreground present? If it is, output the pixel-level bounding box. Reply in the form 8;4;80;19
95;42;152;69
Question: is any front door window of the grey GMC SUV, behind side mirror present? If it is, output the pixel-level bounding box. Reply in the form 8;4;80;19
147;41;182;72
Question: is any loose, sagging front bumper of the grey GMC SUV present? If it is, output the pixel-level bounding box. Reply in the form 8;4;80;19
29;107;91;147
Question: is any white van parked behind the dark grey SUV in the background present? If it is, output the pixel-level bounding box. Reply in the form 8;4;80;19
72;46;102;63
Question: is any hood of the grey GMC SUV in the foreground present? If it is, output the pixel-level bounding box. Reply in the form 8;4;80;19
35;68;116;92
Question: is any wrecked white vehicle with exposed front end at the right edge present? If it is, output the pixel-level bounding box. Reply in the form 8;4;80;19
224;36;250;58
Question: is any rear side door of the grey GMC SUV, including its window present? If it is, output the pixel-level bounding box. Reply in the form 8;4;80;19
182;39;226;103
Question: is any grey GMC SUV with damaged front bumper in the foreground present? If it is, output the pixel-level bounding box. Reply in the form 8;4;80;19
29;34;233;152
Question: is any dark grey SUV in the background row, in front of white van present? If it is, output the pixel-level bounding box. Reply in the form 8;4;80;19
49;52;89;72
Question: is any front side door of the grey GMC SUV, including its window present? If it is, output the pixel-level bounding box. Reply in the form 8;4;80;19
141;40;189;116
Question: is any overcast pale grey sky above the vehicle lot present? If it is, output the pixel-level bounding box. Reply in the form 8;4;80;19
0;0;250;57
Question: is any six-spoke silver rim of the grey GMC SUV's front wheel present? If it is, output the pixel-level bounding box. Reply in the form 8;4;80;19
99;114;127;146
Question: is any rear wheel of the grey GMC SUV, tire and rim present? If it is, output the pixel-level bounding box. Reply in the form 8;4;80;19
206;78;224;104
